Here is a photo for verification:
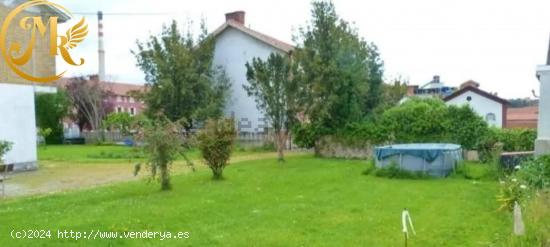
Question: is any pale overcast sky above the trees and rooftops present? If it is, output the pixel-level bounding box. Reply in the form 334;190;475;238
55;0;550;98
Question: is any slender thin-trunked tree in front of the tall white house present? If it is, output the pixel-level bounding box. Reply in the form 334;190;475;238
243;53;298;161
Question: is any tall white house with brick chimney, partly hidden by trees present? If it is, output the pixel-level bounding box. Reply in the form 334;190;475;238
213;11;294;133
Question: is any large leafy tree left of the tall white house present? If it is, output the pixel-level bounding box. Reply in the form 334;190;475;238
132;21;231;130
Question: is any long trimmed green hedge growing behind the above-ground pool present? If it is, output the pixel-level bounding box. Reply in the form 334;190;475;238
339;98;489;149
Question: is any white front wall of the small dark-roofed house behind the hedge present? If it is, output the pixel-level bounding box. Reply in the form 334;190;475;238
447;91;503;128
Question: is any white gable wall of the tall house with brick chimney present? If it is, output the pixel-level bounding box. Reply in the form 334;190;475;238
214;27;279;132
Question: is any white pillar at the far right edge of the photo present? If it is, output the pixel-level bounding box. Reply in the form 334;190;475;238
535;36;550;156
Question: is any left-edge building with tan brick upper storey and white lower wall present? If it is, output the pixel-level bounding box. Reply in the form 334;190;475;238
0;0;69;170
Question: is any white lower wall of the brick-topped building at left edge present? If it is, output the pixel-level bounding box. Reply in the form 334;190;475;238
0;83;37;169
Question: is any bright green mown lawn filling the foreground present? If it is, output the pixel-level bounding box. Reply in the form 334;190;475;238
0;155;511;246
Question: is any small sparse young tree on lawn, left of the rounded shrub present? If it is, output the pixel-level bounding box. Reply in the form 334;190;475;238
134;115;194;190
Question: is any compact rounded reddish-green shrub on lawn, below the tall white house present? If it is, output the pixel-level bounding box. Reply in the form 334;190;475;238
197;119;237;179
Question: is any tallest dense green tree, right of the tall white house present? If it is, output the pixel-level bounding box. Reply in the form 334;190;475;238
293;1;383;134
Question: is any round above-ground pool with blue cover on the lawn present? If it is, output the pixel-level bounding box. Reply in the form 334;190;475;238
374;143;462;177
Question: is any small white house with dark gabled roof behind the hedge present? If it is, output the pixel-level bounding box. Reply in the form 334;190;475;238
443;80;508;128
